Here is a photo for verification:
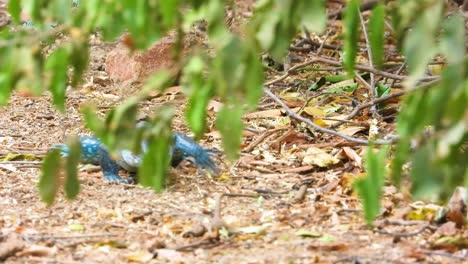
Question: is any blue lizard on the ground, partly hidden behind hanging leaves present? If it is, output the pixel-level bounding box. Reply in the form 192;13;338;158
51;132;218;183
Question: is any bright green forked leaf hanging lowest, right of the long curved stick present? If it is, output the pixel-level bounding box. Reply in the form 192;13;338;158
354;146;388;225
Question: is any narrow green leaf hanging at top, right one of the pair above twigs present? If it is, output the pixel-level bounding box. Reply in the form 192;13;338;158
369;3;385;68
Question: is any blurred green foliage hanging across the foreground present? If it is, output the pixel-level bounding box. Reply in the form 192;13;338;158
0;0;468;221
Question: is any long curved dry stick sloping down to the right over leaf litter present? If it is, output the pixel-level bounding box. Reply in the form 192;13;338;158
263;88;394;145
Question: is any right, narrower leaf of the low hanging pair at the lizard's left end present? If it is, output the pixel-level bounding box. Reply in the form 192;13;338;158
64;136;81;199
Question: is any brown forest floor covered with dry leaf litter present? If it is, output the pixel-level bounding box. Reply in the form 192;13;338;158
0;1;468;263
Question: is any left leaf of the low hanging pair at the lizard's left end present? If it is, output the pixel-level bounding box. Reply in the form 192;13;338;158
39;150;62;205
